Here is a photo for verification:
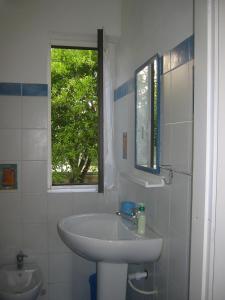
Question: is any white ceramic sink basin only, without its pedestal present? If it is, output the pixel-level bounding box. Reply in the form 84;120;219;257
58;214;162;263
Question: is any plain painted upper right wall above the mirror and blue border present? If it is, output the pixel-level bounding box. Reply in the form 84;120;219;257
117;0;193;85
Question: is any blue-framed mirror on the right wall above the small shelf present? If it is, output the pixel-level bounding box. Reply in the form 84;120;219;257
135;55;160;174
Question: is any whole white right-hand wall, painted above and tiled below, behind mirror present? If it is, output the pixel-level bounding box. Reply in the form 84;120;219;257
115;0;193;300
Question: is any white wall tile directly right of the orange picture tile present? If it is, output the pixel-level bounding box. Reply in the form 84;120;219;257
22;161;47;194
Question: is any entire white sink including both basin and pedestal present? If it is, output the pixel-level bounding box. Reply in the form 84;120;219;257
57;214;162;300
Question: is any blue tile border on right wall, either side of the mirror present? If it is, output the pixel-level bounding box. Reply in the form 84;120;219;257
114;35;194;101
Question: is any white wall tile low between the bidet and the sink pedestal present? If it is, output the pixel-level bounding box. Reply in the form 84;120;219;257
49;253;74;283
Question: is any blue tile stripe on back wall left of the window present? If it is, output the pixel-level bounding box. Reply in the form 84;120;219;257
0;82;48;96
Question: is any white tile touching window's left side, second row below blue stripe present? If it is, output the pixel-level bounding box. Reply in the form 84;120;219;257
22;129;48;160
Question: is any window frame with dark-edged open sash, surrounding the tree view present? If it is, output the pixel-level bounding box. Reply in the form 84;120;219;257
48;29;104;193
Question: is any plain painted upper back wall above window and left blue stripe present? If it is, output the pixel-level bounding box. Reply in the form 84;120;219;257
0;0;121;83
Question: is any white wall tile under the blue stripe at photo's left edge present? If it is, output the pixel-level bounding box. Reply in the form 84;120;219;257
0;96;21;129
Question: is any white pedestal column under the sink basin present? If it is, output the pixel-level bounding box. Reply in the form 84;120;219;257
97;262;128;300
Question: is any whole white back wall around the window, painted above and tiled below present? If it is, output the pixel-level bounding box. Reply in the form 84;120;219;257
0;0;121;300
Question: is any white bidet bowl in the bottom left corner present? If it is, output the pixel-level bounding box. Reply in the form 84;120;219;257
0;264;42;300
